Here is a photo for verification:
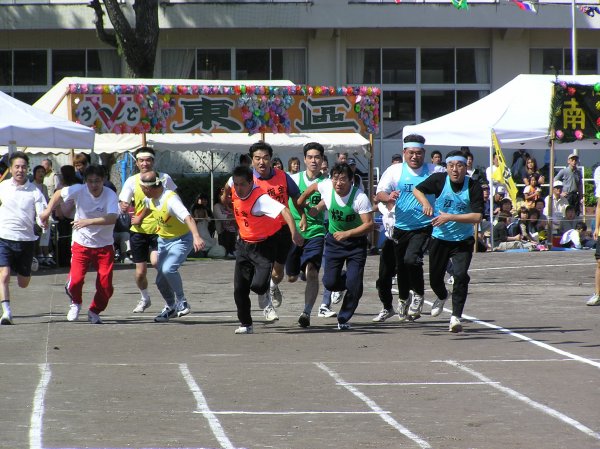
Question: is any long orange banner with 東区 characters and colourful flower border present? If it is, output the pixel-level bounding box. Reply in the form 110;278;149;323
68;84;381;135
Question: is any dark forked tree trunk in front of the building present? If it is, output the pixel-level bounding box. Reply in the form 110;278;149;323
88;0;160;78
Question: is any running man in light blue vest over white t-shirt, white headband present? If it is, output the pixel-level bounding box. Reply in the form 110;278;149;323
376;134;444;321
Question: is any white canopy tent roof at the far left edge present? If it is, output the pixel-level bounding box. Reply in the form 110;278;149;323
0;92;95;148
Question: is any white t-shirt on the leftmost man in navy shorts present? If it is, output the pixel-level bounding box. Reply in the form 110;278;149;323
0;179;46;242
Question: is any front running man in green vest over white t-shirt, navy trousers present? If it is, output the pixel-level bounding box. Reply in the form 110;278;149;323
311;164;373;330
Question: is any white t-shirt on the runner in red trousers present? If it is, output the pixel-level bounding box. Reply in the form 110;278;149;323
60;184;119;248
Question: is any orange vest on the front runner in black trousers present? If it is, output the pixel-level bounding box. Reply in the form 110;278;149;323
231;187;281;243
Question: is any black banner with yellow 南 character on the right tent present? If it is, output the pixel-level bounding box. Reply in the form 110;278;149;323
550;81;600;143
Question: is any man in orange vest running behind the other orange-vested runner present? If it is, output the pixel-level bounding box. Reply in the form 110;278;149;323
223;141;300;322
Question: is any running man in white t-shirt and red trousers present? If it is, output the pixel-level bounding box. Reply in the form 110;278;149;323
40;165;119;324
